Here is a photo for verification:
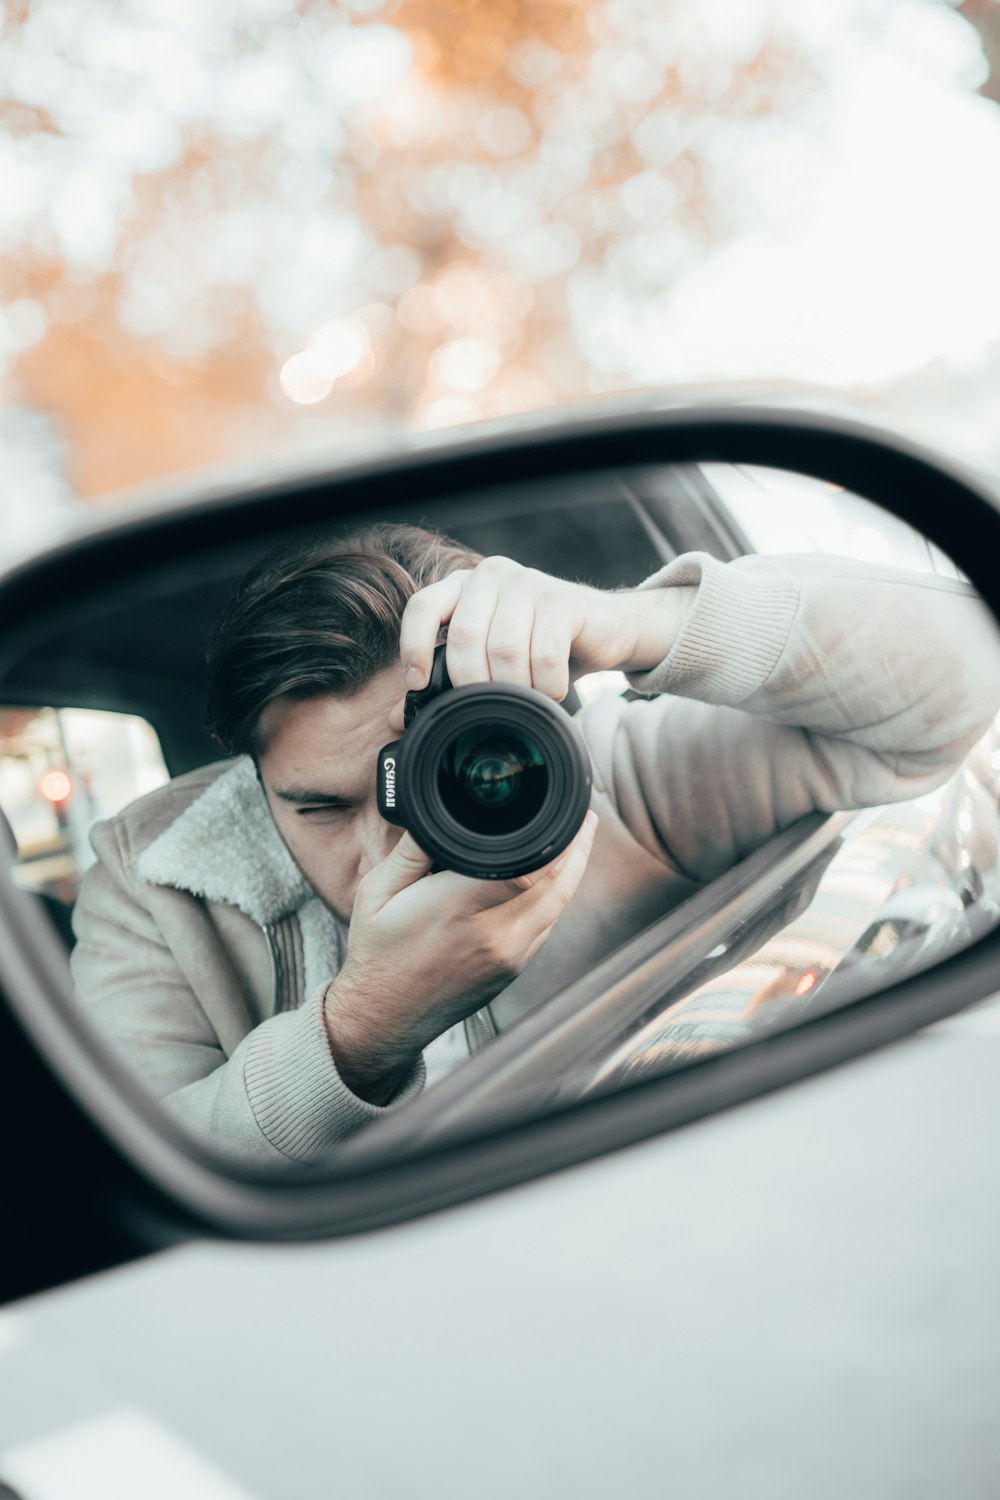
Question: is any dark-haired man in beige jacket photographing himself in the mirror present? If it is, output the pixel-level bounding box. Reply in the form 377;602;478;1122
73;527;1000;1163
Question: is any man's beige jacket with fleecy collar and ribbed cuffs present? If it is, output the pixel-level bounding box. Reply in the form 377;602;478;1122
73;554;1000;1163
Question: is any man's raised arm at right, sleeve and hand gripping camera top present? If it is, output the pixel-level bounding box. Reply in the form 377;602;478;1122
397;554;1000;881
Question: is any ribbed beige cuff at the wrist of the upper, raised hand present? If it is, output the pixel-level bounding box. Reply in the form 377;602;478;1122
628;552;799;707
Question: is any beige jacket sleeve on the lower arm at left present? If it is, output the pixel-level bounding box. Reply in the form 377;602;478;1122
72;821;423;1164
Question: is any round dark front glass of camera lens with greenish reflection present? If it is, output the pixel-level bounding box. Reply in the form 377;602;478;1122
438;725;549;834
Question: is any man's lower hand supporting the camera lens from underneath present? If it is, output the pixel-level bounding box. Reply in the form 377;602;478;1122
324;812;597;1104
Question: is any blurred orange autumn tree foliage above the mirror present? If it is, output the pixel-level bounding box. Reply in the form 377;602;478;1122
0;0;976;497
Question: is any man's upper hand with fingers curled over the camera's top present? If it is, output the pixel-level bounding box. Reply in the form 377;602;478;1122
390;557;696;729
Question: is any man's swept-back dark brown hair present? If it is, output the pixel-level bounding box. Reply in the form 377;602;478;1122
205;524;480;759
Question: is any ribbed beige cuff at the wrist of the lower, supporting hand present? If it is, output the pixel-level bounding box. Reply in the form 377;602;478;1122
243;984;424;1161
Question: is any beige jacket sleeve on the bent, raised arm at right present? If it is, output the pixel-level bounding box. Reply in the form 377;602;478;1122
580;552;1000;882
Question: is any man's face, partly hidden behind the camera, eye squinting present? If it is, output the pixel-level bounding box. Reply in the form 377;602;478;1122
259;668;403;918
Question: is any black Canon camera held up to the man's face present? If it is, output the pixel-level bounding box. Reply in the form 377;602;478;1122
376;647;591;881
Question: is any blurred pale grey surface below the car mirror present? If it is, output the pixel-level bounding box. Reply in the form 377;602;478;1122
0;999;1000;1500
